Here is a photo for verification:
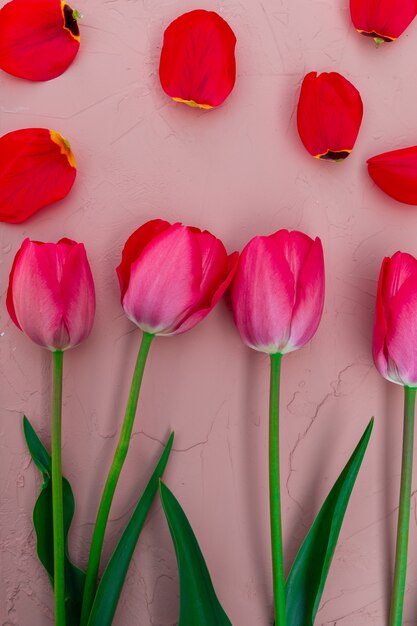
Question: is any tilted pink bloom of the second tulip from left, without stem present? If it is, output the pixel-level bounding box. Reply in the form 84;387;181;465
117;220;239;335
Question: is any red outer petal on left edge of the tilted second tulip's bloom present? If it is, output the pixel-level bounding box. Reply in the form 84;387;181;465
116;219;171;302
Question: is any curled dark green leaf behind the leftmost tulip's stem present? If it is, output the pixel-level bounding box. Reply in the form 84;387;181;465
23;417;85;626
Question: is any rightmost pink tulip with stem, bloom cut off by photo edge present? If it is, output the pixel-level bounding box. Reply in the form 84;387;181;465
373;252;417;626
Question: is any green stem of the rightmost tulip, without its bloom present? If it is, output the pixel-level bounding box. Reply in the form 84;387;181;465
389;387;417;626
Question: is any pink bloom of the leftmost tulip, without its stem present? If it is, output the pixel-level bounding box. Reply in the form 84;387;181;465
7;239;96;351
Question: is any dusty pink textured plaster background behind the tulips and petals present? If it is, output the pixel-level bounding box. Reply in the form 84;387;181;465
0;0;417;626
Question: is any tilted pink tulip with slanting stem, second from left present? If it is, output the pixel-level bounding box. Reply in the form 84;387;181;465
80;220;239;626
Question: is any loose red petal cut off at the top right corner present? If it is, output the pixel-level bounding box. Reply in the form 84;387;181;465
350;0;417;41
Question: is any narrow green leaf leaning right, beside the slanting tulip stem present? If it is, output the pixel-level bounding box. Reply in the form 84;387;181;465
88;433;174;626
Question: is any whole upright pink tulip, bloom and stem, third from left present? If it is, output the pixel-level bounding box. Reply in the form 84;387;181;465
232;230;324;625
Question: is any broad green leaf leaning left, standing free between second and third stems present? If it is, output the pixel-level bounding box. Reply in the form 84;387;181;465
159;482;231;626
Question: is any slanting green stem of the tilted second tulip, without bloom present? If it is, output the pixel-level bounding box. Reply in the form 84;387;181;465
80;333;154;626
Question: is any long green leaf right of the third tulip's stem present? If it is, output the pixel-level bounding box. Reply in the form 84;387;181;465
285;418;374;626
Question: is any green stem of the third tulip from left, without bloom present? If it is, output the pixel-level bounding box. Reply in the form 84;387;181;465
269;354;287;626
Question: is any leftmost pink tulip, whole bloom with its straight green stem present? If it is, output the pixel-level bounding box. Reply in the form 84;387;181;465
7;234;95;626
